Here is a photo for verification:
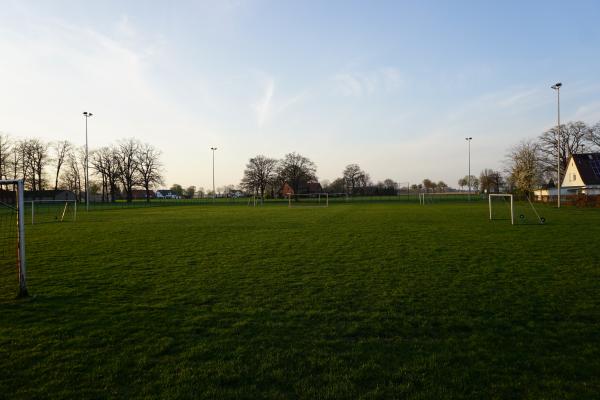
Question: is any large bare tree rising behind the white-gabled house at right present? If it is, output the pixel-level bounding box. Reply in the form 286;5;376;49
539;121;592;180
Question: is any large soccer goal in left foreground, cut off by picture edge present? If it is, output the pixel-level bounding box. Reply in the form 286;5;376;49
0;180;27;297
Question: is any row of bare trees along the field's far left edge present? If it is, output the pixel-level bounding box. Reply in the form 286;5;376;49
0;133;163;202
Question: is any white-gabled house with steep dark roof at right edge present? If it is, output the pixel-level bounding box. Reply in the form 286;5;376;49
561;153;600;196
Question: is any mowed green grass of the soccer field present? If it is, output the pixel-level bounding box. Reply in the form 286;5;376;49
0;203;600;399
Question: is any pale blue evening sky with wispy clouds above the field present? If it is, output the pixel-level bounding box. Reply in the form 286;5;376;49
0;0;600;189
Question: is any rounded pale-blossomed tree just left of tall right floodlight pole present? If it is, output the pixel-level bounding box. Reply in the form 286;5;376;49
508;140;543;195
